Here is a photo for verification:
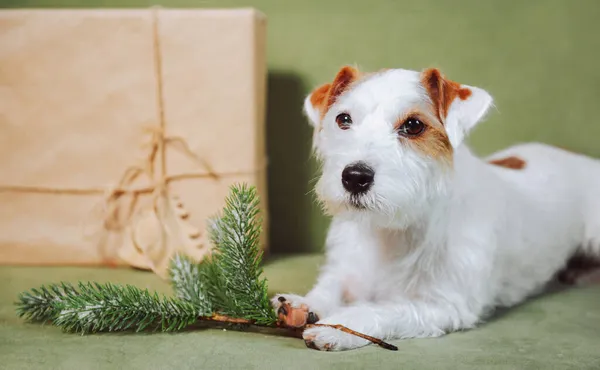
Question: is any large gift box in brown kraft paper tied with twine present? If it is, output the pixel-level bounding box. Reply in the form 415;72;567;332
0;8;268;271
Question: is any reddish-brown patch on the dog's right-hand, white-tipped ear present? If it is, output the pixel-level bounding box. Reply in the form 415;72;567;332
421;68;472;123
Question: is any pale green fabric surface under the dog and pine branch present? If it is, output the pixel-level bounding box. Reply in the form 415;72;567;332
0;255;600;370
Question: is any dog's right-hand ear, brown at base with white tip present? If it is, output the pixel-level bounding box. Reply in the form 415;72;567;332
421;68;492;147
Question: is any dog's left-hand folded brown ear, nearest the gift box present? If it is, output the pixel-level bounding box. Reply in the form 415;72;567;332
304;66;359;127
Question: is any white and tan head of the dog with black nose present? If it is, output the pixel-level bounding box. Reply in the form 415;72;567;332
304;67;492;227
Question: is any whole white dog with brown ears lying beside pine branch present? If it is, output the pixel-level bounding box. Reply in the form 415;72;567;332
273;67;600;350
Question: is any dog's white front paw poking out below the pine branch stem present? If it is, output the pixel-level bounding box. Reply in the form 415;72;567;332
302;326;370;351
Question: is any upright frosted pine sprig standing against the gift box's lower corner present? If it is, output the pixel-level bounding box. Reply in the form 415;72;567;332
205;185;277;325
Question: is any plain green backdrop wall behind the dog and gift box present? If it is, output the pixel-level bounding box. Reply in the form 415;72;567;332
0;0;600;253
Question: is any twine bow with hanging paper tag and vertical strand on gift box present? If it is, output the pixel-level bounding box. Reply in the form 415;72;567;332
104;8;219;277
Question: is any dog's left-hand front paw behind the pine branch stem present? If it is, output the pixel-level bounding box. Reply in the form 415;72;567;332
271;294;319;328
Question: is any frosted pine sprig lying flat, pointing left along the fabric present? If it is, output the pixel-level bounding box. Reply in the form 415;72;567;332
17;283;198;334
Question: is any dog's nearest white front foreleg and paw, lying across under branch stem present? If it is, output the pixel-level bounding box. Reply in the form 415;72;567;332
303;302;478;351
